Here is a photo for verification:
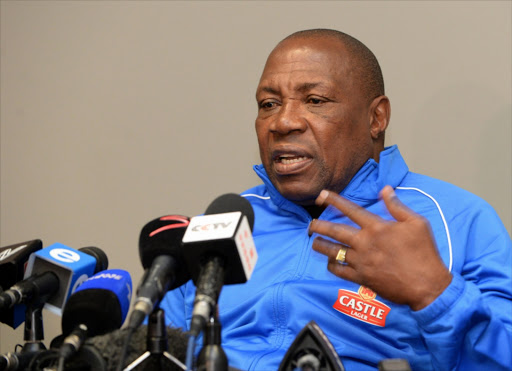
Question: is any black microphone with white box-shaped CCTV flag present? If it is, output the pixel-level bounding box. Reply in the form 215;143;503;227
183;193;258;337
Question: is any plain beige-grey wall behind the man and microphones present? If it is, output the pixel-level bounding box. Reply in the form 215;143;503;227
0;1;512;353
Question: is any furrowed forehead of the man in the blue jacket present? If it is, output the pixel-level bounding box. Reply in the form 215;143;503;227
258;38;351;92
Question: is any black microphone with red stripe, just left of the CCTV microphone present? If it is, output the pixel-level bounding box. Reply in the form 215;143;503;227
128;215;190;328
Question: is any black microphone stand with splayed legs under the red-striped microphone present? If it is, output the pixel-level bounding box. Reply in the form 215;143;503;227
124;307;186;371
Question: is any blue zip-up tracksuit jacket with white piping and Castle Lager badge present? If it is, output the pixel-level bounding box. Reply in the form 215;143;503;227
161;146;512;371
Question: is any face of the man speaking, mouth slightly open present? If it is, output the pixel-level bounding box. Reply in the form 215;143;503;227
256;38;373;205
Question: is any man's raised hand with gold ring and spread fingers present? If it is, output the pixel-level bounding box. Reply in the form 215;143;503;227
309;186;452;310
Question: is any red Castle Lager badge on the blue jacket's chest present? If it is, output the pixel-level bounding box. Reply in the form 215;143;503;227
332;286;391;327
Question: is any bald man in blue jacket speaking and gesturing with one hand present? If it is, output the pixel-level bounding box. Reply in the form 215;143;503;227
162;30;512;370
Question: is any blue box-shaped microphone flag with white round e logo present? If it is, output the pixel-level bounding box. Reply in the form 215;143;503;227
25;243;96;316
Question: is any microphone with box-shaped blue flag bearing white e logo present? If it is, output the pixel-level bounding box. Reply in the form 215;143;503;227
0;243;108;315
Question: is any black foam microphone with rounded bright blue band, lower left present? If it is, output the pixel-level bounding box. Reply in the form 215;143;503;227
60;269;132;359
